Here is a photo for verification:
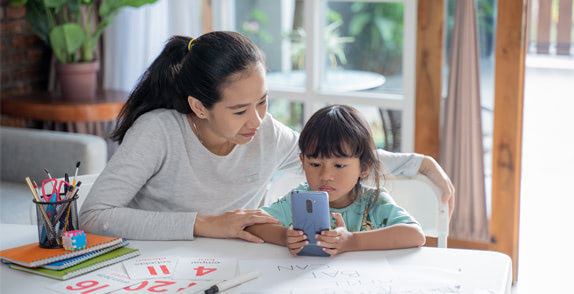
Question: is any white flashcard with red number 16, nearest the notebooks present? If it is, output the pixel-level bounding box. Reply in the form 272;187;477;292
48;272;139;294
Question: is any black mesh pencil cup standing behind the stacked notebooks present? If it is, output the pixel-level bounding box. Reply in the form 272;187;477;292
32;194;79;248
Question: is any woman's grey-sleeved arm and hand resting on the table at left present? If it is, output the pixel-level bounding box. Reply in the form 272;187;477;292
80;114;276;241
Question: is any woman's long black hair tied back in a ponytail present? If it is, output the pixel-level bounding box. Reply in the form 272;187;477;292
111;32;265;143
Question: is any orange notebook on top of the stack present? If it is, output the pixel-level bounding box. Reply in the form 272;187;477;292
0;233;122;267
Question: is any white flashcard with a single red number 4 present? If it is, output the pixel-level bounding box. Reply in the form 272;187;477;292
173;258;237;280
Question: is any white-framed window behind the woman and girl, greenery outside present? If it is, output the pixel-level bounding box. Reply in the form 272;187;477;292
213;0;417;152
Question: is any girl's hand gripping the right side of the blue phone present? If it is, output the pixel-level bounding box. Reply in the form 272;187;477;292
315;213;353;255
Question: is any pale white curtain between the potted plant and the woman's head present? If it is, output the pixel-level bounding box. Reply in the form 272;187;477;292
104;0;202;91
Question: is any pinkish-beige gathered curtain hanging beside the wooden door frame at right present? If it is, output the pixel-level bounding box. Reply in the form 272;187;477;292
440;0;489;241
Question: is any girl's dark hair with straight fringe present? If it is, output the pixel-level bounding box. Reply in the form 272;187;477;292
299;105;382;205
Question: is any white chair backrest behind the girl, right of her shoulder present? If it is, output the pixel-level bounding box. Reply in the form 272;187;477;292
383;174;449;248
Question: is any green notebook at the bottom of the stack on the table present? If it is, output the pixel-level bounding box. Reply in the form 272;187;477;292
10;247;140;280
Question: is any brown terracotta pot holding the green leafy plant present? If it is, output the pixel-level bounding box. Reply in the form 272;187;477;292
56;60;100;101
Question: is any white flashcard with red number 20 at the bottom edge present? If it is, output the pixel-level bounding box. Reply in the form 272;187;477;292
113;278;215;294
